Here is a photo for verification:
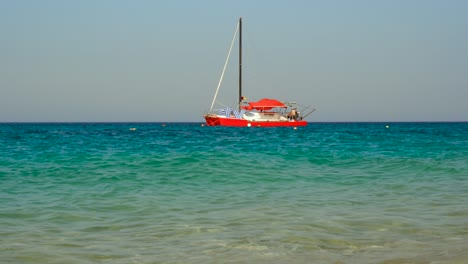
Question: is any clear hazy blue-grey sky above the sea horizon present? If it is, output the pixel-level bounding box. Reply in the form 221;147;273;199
0;0;468;122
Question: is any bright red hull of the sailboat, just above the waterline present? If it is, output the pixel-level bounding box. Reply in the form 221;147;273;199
205;116;307;127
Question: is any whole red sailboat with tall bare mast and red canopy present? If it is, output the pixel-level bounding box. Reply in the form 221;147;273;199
204;18;315;127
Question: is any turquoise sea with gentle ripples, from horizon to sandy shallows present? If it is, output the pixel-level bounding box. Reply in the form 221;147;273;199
0;122;468;264
